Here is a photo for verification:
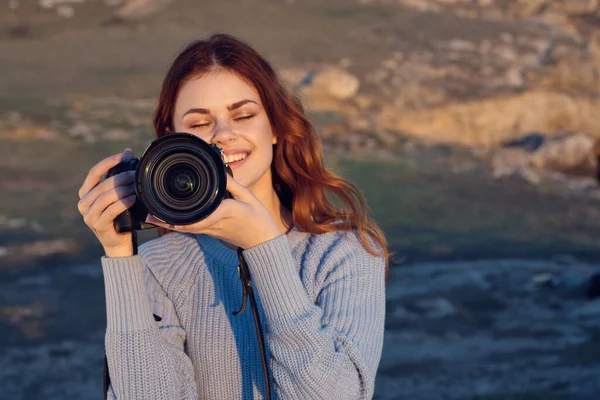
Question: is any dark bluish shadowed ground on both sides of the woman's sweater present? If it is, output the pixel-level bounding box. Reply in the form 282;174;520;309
0;259;600;400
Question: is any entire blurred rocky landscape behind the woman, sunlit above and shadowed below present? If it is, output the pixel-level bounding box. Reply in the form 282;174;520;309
0;0;600;400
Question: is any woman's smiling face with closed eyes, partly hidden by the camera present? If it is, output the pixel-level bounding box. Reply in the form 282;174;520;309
173;69;277;195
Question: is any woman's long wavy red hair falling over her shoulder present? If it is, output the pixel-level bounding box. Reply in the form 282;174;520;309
153;34;390;265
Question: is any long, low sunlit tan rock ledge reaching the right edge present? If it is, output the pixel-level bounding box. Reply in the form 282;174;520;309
377;90;600;148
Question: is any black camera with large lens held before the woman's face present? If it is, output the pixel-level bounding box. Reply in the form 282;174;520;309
105;132;233;233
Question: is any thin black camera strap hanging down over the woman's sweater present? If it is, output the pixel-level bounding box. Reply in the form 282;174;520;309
102;231;271;400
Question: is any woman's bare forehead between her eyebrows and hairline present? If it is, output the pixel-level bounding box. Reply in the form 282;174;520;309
175;69;261;114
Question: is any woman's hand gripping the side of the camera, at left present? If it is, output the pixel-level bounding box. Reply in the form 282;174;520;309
77;149;135;257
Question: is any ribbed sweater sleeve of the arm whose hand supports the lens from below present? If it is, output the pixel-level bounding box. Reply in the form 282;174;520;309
244;234;385;399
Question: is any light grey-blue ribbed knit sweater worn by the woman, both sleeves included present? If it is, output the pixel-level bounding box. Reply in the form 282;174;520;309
102;229;385;400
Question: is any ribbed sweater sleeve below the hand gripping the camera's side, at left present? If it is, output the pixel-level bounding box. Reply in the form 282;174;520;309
102;255;198;400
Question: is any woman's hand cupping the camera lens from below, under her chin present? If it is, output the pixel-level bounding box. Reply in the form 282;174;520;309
146;174;282;249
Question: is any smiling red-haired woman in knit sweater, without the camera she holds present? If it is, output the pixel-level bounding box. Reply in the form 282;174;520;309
78;35;389;400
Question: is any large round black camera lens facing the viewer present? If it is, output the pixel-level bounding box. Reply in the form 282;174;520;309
139;133;227;225
